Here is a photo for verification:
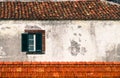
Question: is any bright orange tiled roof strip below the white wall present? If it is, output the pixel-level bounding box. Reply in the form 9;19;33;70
0;62;120;78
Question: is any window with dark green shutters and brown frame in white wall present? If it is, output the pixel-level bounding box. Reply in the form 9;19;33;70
22;30;45;54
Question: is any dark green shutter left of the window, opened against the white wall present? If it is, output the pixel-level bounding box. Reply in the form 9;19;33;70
21;33;28;52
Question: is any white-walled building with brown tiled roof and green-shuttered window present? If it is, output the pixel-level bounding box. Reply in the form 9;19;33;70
0;1;120;61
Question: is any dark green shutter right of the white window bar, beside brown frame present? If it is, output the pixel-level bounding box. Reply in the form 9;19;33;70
36;33;42;53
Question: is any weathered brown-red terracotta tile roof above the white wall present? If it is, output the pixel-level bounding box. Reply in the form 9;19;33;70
0;1;120;20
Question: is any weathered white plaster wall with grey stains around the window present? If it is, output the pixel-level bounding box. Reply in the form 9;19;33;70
0;20;120;61
